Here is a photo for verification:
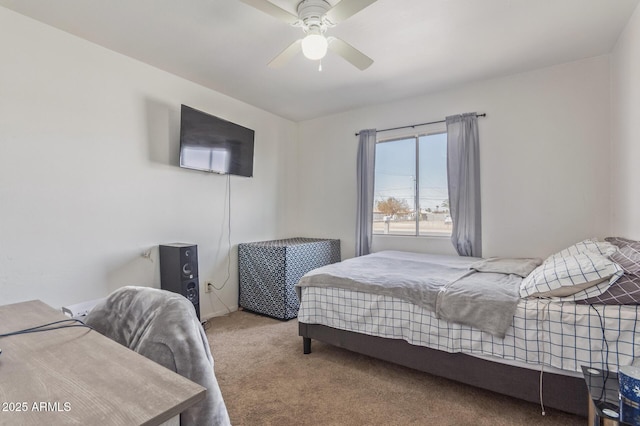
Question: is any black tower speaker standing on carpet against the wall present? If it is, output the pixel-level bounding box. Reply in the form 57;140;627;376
160;243;200;319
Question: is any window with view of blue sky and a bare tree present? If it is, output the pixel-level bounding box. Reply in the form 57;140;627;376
373;133;452;236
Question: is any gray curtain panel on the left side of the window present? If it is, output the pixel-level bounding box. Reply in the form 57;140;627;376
356;129;376;256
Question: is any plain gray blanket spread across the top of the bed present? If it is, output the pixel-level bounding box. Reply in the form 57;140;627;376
296;251;522;338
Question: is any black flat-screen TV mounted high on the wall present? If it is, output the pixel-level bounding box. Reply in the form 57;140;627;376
180;105;255;177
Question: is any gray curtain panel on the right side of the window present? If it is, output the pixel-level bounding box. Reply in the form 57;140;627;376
446;112;482;257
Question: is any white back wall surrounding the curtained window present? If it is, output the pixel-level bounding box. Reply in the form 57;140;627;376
298;56;611;257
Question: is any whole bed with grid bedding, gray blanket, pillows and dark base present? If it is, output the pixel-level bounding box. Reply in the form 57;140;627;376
296;238;640;417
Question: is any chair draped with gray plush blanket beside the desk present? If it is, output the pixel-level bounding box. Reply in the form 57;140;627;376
85;286;231;426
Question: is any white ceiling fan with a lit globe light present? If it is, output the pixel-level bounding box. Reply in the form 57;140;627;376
240;0;376;70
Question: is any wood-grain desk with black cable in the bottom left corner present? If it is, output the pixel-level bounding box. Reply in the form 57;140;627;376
0;301;206;426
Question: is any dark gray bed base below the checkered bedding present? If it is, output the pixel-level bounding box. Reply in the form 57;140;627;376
299;323;589;417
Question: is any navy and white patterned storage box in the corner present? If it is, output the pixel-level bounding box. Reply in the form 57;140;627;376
238;238;340;319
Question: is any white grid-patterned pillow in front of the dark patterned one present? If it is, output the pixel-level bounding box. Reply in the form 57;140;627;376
520;250;623;301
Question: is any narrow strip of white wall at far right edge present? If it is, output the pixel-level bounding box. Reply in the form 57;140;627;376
611;3;640;240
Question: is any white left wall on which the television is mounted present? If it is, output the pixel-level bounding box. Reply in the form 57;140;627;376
0;8;297;317
